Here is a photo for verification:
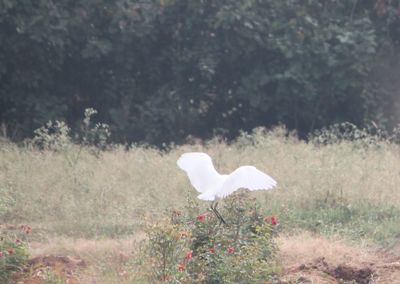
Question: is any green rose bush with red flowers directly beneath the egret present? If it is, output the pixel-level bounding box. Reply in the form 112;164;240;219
140;194;278;283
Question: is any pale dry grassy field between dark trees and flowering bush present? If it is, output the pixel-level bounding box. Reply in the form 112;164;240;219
0;129;400;283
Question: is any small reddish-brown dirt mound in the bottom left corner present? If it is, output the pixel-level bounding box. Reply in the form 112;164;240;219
15;255;86;284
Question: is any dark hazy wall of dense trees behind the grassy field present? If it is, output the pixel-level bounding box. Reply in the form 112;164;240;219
0;0;400;145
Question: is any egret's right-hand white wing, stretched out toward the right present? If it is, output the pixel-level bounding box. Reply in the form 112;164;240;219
216;166;277;198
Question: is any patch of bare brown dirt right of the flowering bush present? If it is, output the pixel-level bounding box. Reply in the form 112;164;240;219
279;233;400;284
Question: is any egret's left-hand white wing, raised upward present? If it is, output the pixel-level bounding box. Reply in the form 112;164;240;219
177;152;222;193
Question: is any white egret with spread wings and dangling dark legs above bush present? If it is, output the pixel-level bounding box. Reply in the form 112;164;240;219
177;152;277;223
